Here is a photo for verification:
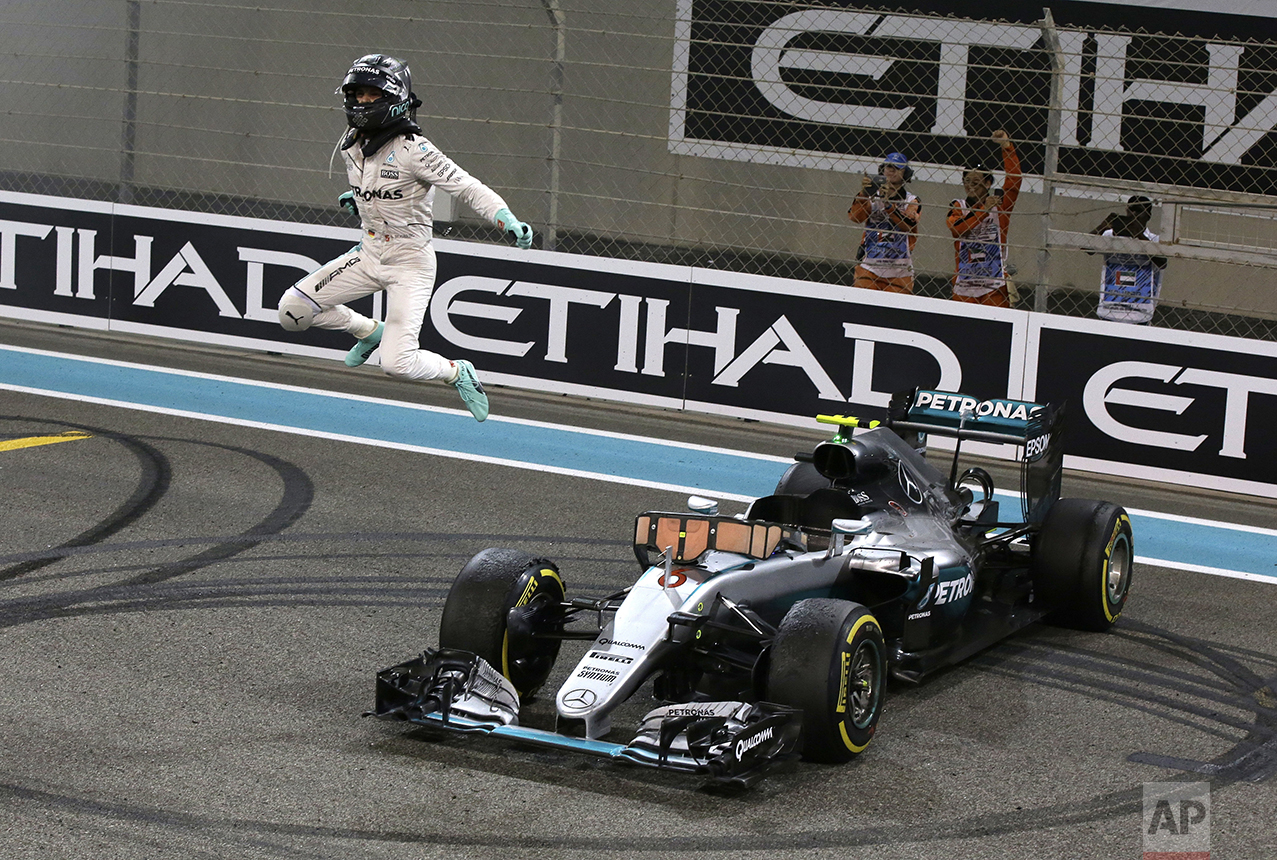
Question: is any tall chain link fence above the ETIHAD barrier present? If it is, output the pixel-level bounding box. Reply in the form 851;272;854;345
0;0;1277;340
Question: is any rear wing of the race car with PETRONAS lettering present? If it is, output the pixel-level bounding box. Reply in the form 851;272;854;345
884;388;1064;523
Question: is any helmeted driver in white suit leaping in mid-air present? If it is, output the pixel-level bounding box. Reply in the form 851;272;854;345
278;54;533;420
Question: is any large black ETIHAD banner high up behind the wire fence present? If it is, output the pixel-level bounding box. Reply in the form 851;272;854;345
669;0;1277;192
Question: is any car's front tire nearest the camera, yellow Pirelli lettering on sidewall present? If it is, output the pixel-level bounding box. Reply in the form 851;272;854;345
767;598;886;762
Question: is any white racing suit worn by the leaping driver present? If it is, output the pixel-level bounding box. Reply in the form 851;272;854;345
280;133;506;380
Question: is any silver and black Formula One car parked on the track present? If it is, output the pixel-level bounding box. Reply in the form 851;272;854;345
372;390;1133;785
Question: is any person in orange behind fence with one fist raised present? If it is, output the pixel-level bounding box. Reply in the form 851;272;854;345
946;130;1020;308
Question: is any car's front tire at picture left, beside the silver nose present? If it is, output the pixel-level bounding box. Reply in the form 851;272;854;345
439;548;563;698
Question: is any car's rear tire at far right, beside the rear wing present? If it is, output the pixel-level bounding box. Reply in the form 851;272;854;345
1033;498;1135;631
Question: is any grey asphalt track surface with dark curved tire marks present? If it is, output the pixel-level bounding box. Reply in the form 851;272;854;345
0;322;1277;860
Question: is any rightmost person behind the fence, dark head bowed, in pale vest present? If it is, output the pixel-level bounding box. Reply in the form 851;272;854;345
1087;194;1166;325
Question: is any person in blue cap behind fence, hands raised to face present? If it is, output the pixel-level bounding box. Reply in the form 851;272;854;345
847;152;922;293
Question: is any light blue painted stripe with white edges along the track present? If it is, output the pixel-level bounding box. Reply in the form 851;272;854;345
0;346;1277;583
